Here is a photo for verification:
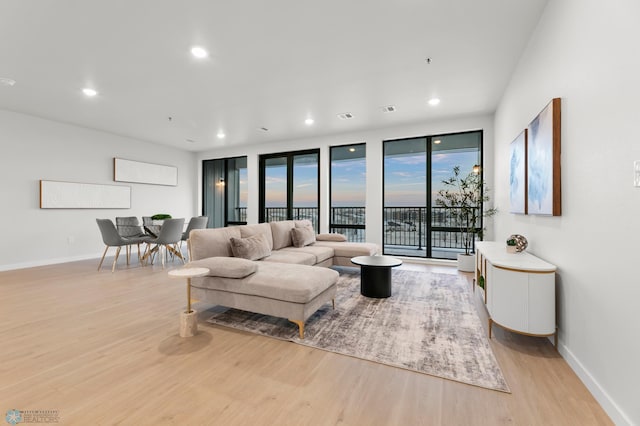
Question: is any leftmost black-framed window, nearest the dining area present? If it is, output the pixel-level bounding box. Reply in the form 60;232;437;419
202;157;248;228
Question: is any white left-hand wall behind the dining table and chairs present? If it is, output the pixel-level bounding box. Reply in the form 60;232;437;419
0;110;198;270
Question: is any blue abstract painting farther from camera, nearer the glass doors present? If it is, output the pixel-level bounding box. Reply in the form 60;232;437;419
509;129;528;214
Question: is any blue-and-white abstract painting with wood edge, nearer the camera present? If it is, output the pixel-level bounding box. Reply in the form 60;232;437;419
527;98;562;216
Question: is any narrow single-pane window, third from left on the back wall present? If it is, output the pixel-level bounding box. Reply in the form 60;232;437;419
329;143;367;242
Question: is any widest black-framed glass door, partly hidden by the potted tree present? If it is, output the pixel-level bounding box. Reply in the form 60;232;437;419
383;131;482;259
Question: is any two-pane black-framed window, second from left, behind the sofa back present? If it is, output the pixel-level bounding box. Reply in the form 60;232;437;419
259;149;320;231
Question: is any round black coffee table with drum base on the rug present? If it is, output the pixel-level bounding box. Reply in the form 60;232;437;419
351;256;402;298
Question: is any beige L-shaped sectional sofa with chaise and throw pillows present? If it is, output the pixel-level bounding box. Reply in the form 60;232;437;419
188;220;379;338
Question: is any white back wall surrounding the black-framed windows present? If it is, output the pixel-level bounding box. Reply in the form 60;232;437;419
198;115;493;251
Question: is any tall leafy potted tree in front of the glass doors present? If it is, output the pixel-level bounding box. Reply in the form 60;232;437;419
436;166;498;272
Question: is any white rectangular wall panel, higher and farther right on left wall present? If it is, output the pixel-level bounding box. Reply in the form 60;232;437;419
113;158;178;186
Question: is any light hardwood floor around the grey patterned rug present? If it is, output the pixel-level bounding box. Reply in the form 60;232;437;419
0;260;611;425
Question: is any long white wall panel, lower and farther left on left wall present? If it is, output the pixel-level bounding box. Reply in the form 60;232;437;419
40;180;131;209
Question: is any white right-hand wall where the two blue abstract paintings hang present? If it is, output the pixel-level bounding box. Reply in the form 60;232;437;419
494;0;640;424
